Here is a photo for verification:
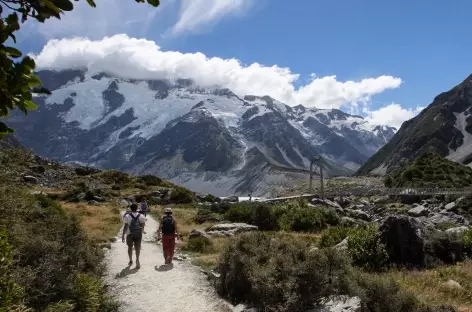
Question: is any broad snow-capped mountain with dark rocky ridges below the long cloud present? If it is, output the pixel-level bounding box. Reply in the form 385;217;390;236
8;70;395;195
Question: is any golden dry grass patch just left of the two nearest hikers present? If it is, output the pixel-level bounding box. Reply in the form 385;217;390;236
61;202;121;242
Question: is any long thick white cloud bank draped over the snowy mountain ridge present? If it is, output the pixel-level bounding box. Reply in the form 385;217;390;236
33;35;402;108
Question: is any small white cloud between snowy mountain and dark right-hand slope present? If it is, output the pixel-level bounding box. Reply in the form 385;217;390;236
364;103;424;129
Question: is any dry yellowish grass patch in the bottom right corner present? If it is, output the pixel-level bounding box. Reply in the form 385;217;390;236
387;260;472;312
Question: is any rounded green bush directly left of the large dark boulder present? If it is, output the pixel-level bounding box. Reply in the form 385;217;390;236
348;224;388;271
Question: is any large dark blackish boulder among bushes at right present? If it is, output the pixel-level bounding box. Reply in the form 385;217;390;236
380;216;425;267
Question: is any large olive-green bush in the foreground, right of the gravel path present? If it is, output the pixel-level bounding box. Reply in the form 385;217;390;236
216;232;349;312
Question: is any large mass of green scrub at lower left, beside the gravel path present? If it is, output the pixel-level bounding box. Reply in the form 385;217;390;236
0;188;114;311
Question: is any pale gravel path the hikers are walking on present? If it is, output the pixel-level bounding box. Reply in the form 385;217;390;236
106;215;232;312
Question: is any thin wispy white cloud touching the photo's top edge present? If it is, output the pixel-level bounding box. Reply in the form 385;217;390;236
171;0;255;35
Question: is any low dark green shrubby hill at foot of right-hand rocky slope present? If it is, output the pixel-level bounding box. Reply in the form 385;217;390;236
386;153;472;188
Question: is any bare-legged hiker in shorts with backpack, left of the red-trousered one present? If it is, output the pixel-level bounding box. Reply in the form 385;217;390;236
121;204;146;269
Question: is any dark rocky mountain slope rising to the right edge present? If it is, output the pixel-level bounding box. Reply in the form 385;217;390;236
357;75;472;175
